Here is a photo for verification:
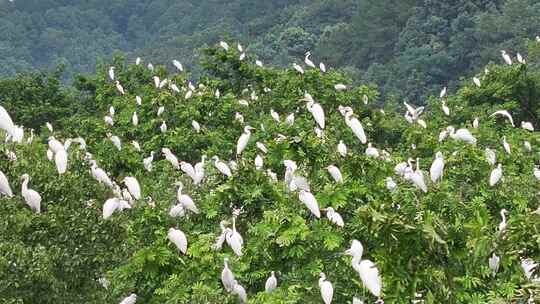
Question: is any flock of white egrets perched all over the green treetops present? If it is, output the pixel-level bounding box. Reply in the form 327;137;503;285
0;42;540;304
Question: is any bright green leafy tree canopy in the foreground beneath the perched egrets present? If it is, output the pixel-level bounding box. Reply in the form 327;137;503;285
0;41;540;303
